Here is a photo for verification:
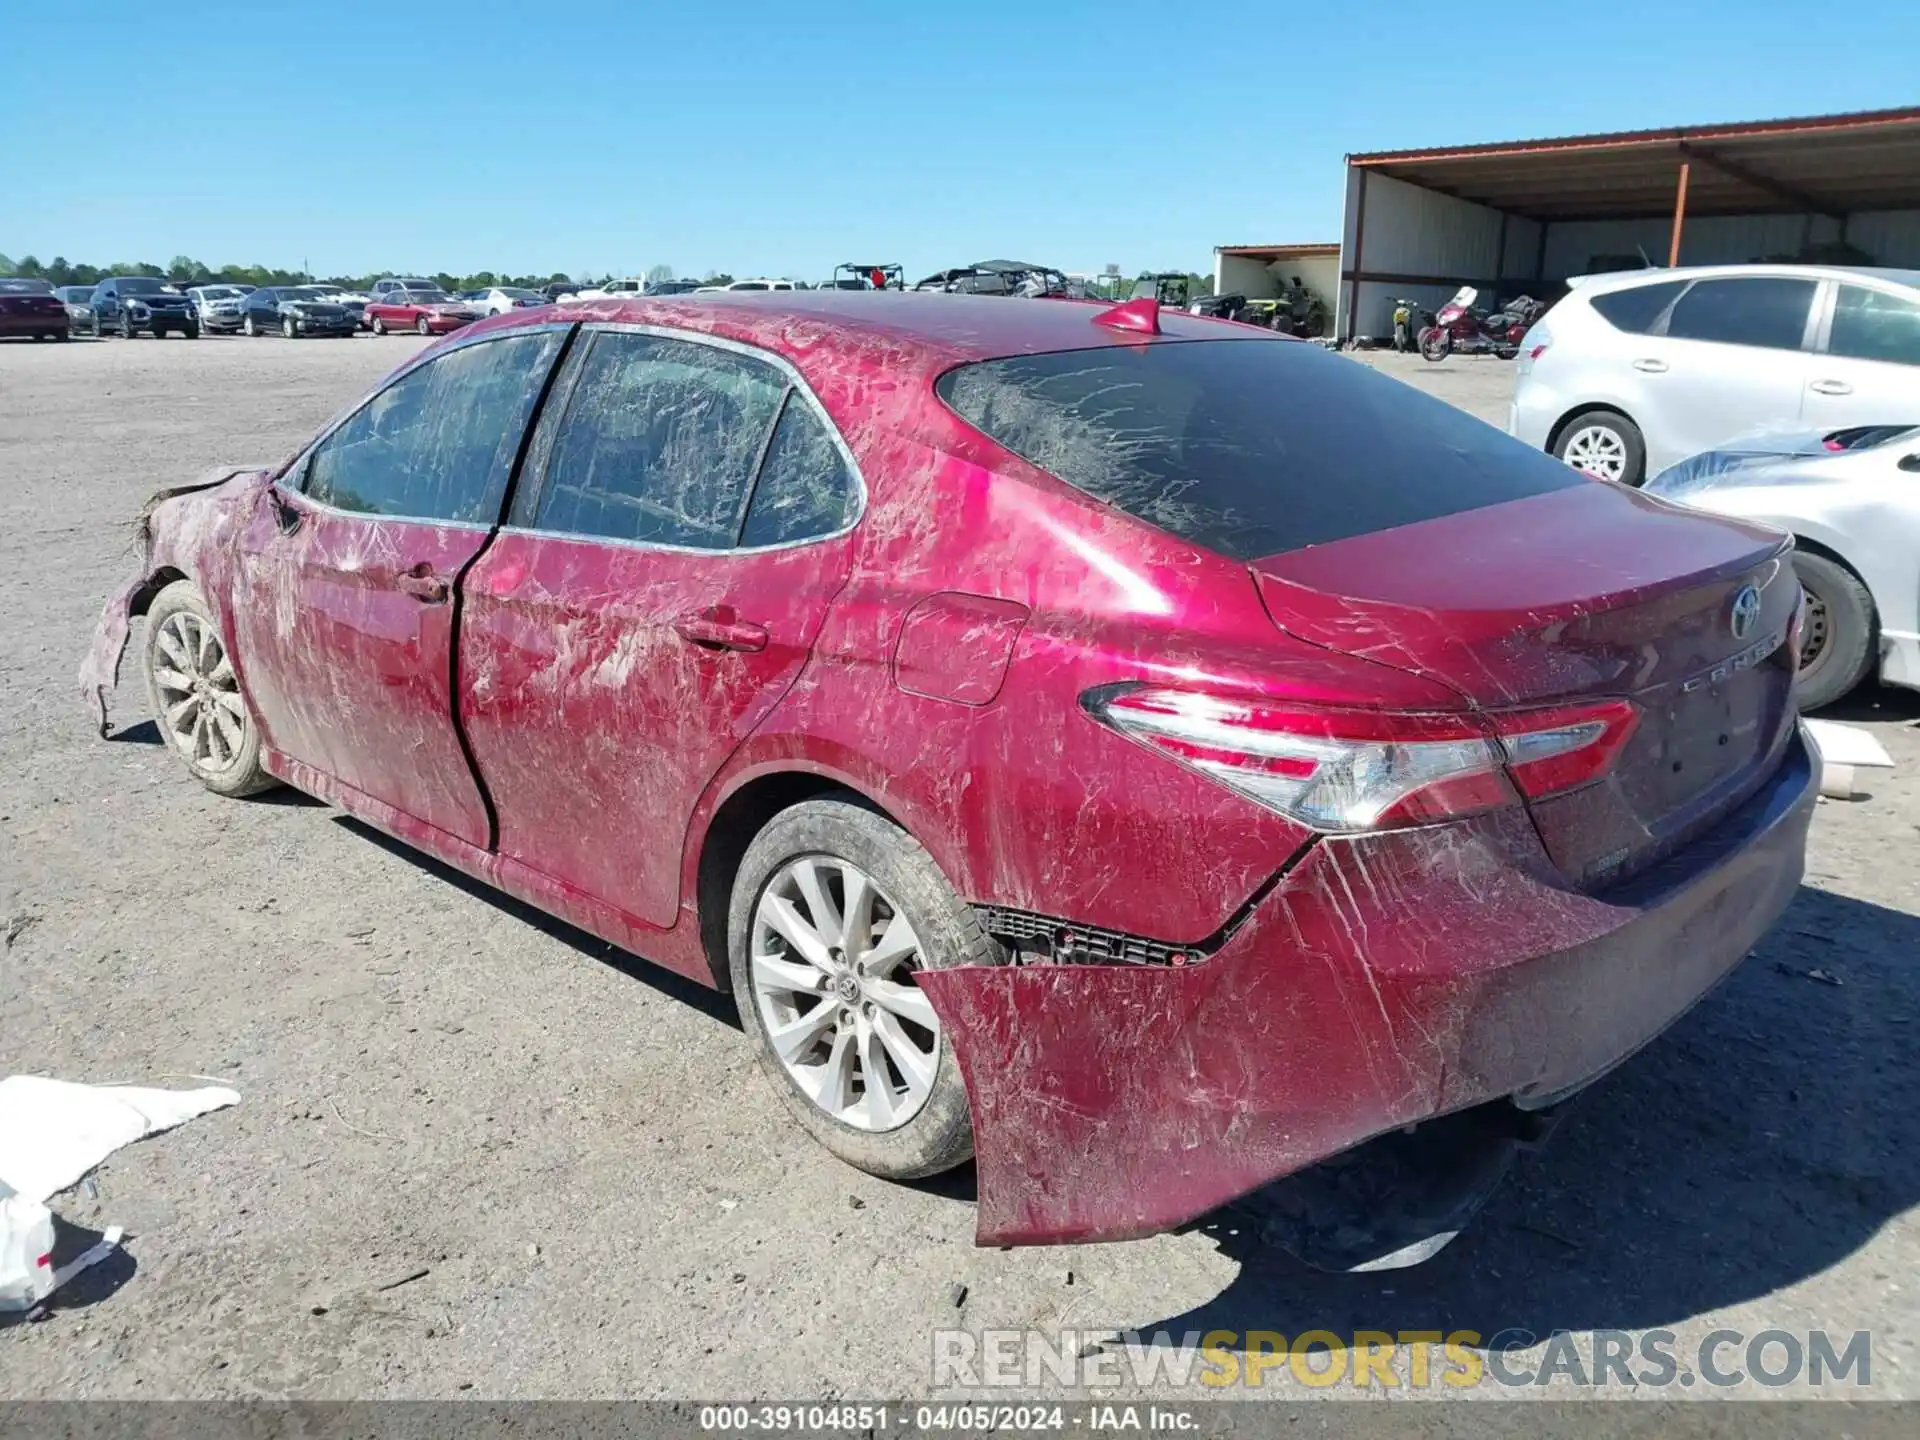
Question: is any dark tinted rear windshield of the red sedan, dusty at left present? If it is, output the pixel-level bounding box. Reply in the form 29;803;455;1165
937;340;1590;561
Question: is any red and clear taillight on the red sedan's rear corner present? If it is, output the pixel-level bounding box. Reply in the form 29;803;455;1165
1081;685;1638;835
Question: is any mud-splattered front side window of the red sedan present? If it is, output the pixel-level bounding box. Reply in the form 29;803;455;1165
305;330;561;524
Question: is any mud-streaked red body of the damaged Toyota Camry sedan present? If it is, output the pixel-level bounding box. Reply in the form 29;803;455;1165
71;292;1812;1244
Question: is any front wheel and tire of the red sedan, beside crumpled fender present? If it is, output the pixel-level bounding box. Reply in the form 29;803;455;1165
144;580;280;797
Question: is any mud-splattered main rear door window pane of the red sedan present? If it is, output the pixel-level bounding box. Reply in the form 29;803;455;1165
534;330;787;549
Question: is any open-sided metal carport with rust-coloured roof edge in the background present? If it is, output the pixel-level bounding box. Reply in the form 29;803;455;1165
1336;108;1920;338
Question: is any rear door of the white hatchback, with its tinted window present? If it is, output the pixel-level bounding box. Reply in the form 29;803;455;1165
1628;275;1820;476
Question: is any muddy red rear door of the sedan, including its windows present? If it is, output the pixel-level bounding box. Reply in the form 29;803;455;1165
461;328;860;929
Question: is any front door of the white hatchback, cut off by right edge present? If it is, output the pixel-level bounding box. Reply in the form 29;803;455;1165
1801;280;1920;430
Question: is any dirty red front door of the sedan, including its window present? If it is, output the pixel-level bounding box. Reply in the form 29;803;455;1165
234;326;566;847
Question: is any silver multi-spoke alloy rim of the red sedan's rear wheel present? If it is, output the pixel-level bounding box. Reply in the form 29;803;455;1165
751;854;941;1131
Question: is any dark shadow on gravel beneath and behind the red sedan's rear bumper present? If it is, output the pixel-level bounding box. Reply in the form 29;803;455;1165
1140;887;1920;1344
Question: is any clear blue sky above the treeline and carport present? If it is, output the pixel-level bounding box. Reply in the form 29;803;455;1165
0;0;1920;278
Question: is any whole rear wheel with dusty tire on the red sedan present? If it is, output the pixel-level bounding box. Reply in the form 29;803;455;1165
728;799;998;1179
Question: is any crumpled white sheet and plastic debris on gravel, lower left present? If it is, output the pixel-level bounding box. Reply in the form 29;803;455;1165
0;1075;240;1311
